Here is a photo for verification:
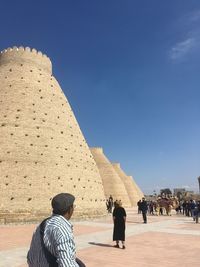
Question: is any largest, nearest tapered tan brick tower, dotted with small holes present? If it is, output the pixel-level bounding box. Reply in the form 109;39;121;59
0;47;105;222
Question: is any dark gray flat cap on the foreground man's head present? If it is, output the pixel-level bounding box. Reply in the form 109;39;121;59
51;193;75;215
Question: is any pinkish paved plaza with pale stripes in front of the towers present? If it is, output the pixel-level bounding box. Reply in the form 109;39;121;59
0;209;200;267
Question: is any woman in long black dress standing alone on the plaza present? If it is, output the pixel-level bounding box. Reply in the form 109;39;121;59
113;201;126;249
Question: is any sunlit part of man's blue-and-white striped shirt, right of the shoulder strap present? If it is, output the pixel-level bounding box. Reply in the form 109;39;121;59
44;215;79;267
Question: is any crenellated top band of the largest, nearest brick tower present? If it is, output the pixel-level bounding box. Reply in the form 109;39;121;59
0;46;52;74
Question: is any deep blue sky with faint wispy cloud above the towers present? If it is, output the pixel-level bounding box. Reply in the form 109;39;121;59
0;0;200;193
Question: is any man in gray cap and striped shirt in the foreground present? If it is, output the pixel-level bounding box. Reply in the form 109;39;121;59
27;193;86;267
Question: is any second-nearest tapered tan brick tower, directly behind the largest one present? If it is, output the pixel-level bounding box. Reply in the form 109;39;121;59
90;147;131;207
